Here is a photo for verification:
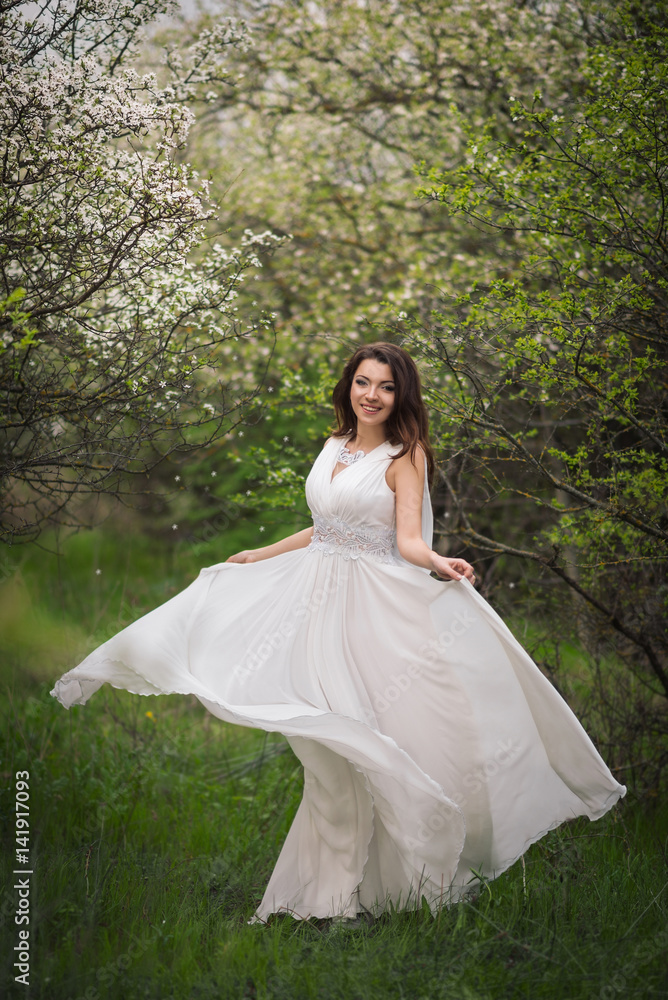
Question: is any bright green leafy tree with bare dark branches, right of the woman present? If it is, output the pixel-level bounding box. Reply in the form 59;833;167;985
404;0;668;712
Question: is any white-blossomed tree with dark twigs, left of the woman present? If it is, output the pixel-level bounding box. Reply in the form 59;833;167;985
0;0;276;542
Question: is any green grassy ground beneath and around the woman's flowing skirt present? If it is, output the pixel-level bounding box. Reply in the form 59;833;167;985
0;539;668;1000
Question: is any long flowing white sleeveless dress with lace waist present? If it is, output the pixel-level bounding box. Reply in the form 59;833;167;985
51;439;626;920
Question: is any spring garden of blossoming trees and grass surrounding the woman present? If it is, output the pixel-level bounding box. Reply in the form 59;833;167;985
0;0;668;1000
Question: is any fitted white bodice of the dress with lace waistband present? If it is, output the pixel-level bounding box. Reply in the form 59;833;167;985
306;438;433;572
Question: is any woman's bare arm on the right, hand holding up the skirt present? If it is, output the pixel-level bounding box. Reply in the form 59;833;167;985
388;446;475;582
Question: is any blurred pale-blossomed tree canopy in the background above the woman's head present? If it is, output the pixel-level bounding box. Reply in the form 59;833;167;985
158;0;605;386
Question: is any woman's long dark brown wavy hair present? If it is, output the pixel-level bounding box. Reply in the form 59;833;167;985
332;341;434;486
